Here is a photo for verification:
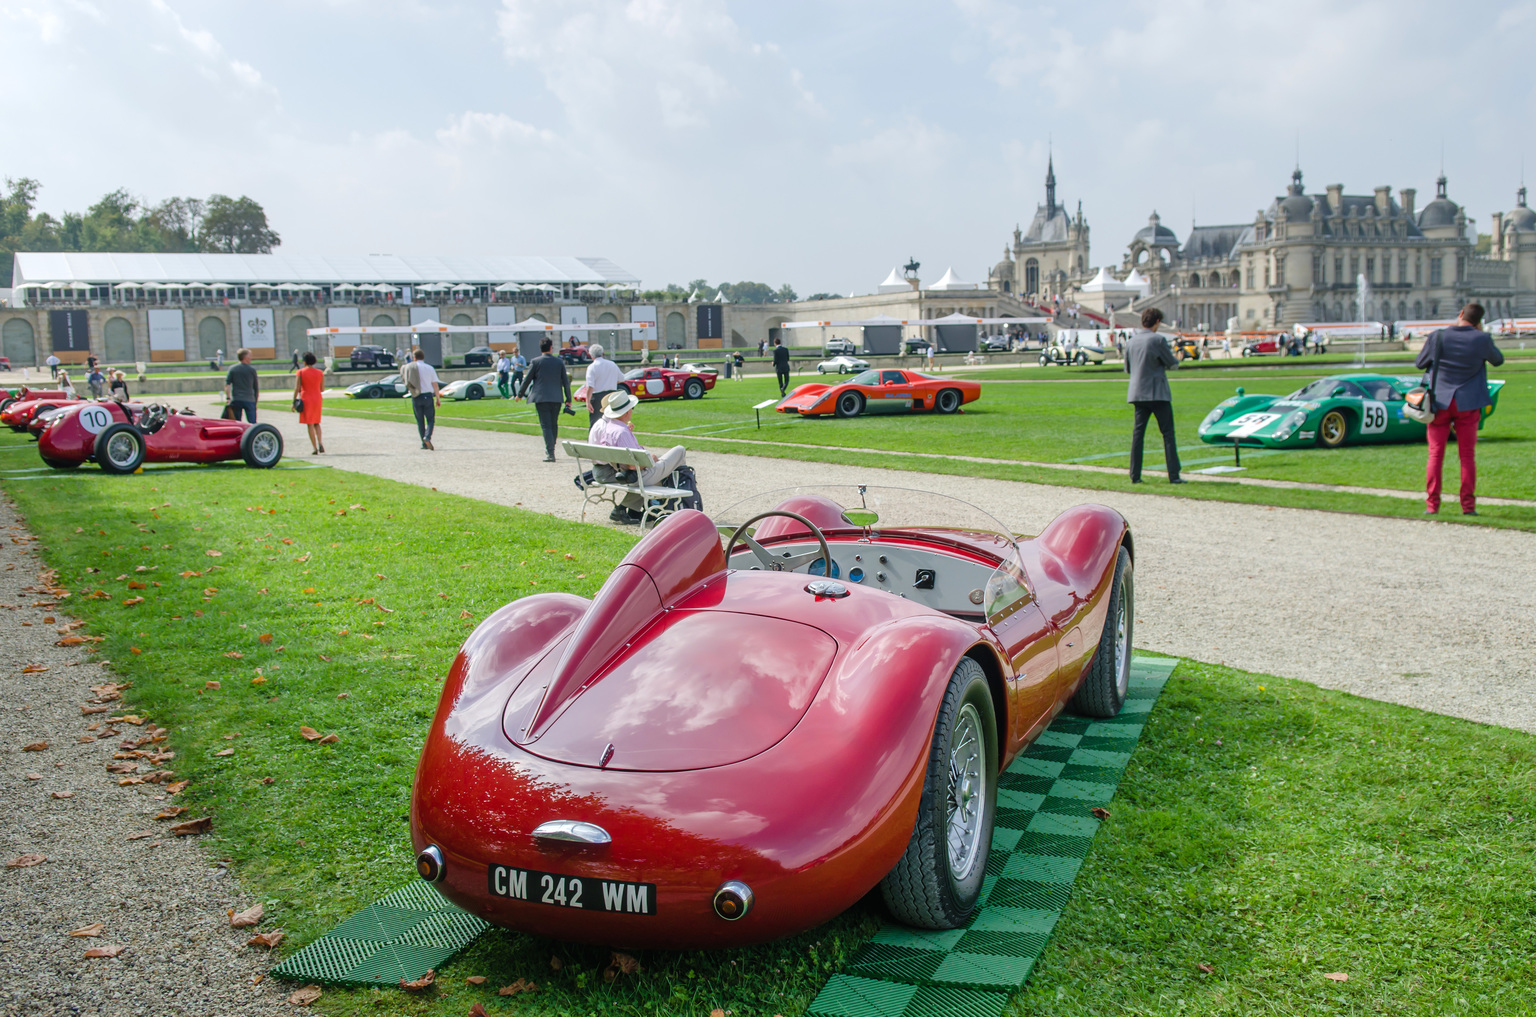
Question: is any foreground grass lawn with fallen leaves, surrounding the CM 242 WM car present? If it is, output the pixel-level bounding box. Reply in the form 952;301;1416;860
0;454;1536;1017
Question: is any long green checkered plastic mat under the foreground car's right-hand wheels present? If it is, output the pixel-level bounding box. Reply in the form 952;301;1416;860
806;658;1178;1017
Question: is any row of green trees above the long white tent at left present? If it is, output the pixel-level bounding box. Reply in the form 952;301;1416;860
0;177;281;286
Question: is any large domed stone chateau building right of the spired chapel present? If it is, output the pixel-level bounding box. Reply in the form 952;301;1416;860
1121;169;1536;330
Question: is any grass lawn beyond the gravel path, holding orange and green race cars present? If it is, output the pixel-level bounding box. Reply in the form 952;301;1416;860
326;358;1536;530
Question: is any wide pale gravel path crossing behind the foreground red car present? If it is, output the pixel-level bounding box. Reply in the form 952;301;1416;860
266;409;1536;733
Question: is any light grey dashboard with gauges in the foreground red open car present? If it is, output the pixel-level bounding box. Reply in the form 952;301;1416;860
731;541;995;615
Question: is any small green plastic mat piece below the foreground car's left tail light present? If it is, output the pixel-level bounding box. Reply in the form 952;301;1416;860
272;880;490;985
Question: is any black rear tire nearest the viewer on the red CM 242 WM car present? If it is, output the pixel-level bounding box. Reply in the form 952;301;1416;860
880;658;997;929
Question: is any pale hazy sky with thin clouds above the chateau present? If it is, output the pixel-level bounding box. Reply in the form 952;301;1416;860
0;0;1536;295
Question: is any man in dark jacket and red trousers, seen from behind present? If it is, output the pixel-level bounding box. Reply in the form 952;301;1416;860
1416;303;1504;516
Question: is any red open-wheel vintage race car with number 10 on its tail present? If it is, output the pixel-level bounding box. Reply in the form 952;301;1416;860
37;402;283;473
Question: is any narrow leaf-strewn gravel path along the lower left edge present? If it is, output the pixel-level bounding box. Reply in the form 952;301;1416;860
0;502;292;1017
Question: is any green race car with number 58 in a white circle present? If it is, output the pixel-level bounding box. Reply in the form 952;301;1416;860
1200;375;1504;449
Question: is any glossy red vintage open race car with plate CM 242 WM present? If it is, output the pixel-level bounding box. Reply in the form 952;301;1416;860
410;487;1134;949
